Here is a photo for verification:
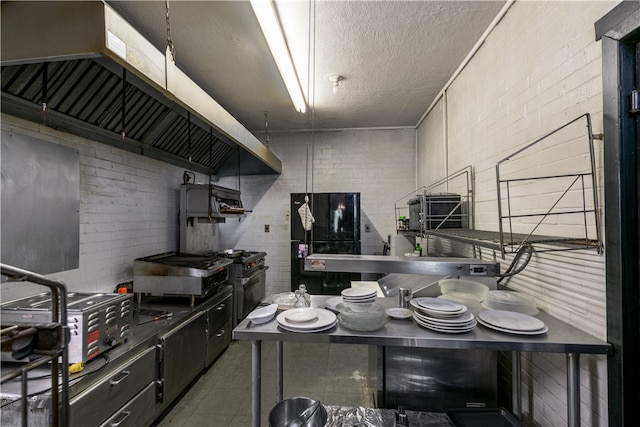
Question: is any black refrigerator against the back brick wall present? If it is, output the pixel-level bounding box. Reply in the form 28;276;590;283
291;193;361;295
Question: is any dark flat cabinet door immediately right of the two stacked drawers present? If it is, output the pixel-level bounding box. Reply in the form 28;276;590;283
160;312;207;408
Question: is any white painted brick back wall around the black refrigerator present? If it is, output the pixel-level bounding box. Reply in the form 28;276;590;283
219;129;416;292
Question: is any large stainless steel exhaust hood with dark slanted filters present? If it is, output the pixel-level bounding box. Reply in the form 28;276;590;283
0;1;282;176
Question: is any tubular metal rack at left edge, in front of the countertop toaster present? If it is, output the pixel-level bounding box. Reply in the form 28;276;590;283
0;264;69;427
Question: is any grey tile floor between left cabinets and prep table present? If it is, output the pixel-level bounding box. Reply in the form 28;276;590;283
155;341;375;427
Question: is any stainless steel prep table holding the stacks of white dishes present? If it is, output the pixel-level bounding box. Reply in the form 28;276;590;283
233;295;611;427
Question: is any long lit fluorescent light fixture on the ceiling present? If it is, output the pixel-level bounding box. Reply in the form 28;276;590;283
251;0;307;113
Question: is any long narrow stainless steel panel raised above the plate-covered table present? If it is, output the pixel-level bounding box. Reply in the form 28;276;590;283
304;254;500;277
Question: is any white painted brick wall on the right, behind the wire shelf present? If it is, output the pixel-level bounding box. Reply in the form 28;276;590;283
418;1;618;426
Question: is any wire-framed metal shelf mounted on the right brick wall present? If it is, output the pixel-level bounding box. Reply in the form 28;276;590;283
396;113;603;259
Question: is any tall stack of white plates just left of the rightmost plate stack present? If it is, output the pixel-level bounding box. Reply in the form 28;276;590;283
409;298;477;334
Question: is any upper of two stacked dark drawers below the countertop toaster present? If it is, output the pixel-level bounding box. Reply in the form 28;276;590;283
69;347;157;427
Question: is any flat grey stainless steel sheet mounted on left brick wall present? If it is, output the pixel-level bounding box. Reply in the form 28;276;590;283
0;130;80;274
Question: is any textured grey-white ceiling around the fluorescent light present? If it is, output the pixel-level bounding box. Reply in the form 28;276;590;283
108;0;505;132
